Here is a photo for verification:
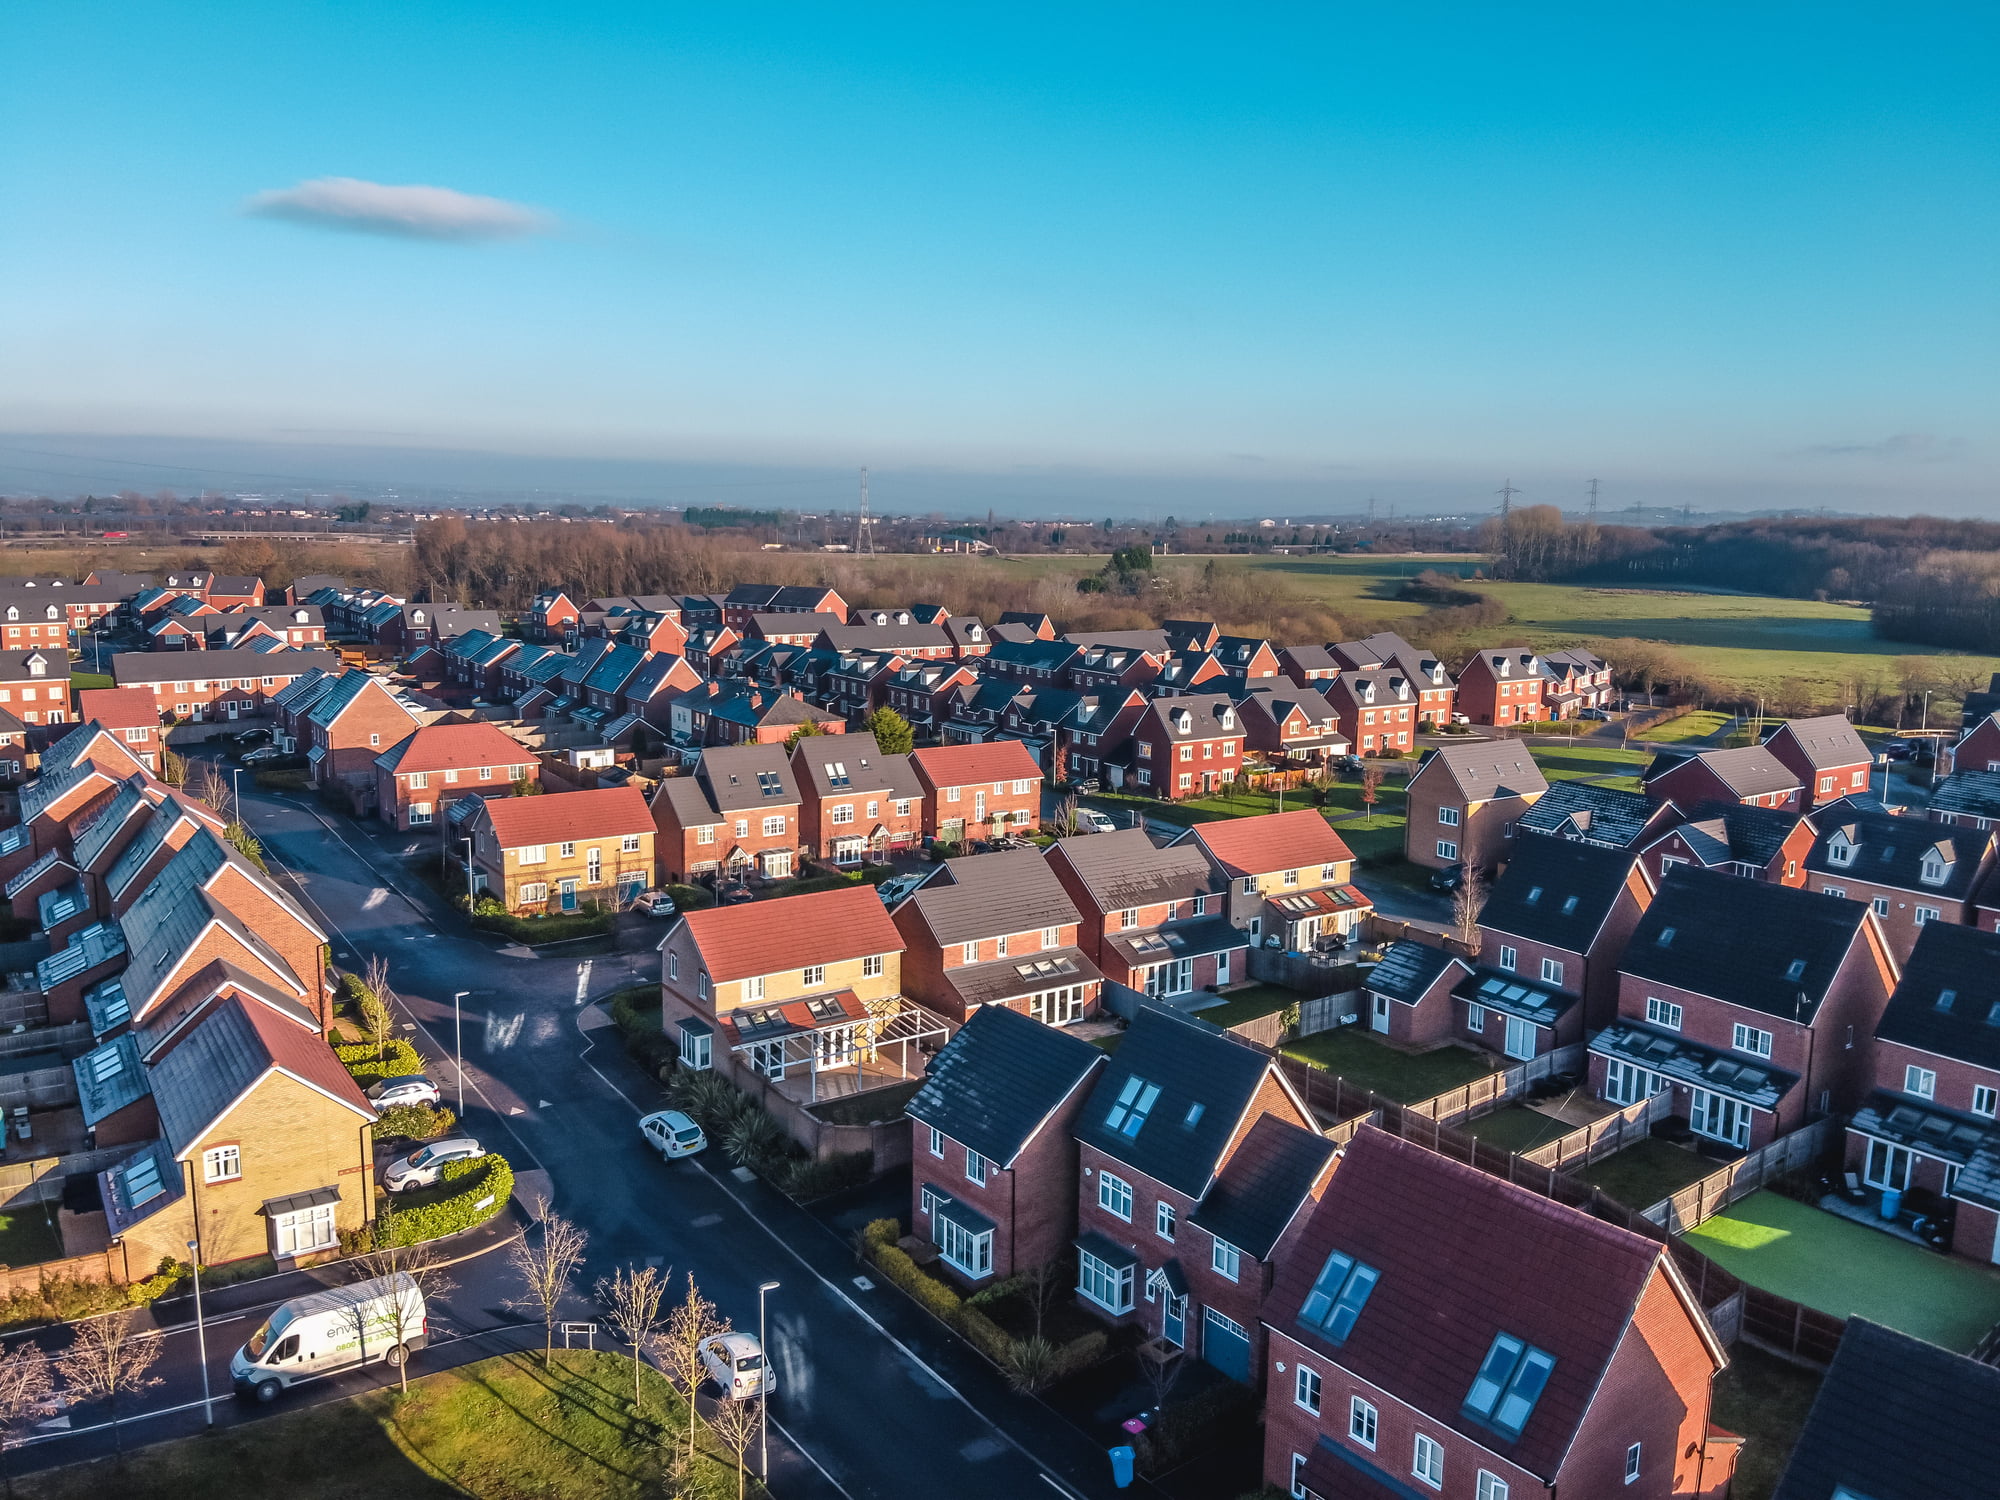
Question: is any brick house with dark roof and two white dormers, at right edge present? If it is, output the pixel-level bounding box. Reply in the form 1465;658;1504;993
1804;804;1996;964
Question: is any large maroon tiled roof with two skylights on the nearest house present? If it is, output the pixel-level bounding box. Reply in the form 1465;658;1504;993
1266;1126;1666;1480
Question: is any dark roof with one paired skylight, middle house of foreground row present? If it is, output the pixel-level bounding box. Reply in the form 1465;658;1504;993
1076;1004;1270;1198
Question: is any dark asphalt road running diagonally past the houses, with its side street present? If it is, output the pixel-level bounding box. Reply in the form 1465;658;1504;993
3;764;1148;1500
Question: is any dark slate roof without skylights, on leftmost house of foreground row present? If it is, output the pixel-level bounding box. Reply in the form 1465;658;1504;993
908;1006;1104;1166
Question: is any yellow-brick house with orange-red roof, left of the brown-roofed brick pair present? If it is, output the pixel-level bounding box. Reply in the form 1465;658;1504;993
458;786;654;916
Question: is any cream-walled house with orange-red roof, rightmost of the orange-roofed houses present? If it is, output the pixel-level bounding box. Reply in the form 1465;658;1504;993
1174;808;1374;952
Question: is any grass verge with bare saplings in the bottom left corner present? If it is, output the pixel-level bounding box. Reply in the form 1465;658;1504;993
14;1350;762;1500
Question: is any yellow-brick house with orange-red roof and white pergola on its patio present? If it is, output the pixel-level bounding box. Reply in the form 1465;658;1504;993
660;886;950;1118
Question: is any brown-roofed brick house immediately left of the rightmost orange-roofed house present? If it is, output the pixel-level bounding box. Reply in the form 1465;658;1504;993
1048;828;1250;1000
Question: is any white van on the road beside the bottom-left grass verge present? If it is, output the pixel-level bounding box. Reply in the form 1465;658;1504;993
230;1272;430;1402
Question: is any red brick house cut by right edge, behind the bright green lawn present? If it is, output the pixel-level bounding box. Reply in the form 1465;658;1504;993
1846;922;2000;1264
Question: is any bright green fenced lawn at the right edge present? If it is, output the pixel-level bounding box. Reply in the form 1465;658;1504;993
1684;1192;2000;1354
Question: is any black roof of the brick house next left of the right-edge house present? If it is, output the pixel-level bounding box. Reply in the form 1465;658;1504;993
1618;866;1868;1024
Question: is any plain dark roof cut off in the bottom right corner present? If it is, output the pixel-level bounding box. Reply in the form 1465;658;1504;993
1772;1318;2000;1500
